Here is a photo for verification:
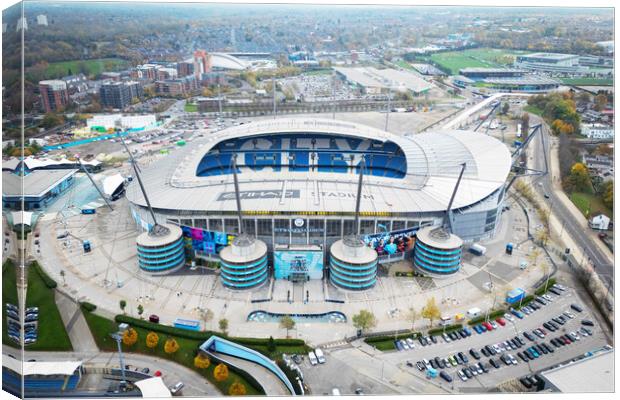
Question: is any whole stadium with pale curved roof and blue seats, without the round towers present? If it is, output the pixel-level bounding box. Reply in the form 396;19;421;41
127;118;511;276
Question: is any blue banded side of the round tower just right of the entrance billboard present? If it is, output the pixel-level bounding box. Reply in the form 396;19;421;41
329;255;377;290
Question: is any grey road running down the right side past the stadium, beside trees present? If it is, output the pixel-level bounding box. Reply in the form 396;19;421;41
530;114;614;293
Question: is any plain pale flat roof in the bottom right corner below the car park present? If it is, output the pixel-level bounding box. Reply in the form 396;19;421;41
540;350;614;393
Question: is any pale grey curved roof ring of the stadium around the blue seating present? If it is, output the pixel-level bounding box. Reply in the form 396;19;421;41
127;118;511;213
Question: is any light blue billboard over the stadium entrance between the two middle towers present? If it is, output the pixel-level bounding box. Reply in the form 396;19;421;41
273;249;323;280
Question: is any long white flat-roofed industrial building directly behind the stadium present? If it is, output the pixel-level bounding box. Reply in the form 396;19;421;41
334;67;433;95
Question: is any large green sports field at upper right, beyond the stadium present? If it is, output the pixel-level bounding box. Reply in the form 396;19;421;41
430;48;525;75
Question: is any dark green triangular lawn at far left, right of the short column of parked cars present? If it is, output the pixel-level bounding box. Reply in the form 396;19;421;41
26;267;73;351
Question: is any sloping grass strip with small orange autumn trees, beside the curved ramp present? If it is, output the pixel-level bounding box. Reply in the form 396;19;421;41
82;310;264;396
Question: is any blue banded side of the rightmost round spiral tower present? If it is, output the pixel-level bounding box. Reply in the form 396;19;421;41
413;240;462;275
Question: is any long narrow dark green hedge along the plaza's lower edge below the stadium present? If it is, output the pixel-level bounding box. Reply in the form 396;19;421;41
114;314;306;346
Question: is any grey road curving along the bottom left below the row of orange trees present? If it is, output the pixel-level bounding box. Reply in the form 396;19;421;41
2;346;221;397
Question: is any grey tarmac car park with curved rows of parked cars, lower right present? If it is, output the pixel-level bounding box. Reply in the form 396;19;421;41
368;289;607;392
